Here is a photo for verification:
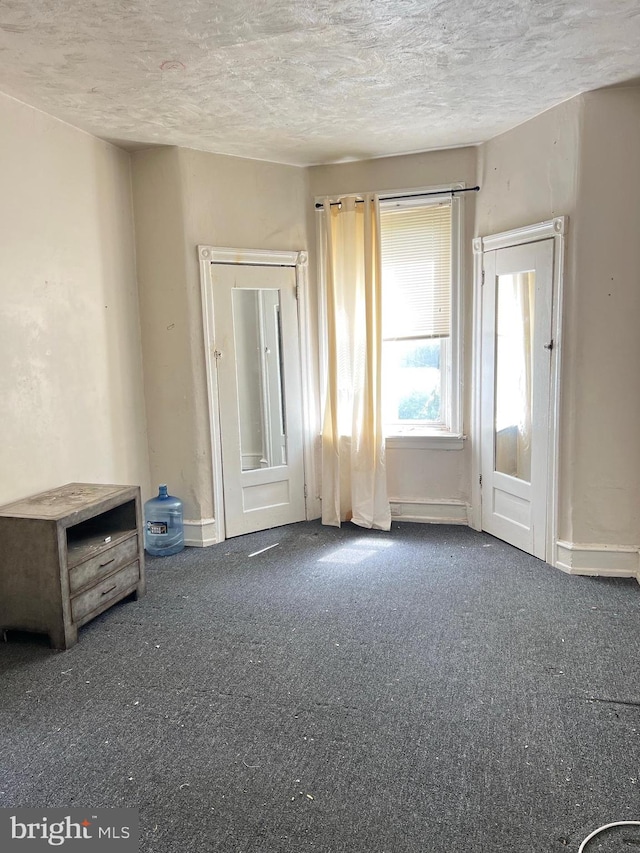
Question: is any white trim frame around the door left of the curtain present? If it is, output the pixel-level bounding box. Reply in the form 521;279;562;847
198;246;319;543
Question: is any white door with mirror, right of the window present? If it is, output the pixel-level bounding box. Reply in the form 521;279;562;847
480;239;554;560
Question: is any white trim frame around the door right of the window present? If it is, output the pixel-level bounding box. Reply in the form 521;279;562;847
469;216;569;566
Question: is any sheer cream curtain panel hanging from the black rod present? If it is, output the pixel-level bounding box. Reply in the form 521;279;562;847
322;195;391;530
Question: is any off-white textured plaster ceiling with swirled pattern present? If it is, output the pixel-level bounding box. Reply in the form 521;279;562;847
0;0;640;165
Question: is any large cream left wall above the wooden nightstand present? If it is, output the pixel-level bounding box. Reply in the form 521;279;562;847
0;95;148;503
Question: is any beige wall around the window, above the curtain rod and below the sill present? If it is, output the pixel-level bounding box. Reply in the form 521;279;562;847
309;148;476;517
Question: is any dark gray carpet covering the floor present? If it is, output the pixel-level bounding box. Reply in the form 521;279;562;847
0;522;640;853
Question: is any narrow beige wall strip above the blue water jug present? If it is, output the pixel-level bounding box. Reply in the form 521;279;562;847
127;148;195;518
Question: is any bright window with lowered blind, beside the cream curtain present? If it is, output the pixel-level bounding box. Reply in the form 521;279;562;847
380;191;460;436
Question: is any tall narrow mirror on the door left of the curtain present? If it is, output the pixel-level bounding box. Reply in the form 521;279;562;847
232;288;287;471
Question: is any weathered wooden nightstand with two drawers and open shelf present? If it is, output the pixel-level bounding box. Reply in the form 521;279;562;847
0;483;145;649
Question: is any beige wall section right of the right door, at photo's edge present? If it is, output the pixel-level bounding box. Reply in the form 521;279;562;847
565;87;640;544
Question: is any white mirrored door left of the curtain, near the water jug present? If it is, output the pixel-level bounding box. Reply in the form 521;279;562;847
211;264;306;536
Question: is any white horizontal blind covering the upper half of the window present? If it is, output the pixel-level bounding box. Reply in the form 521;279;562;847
380;201;451;340
